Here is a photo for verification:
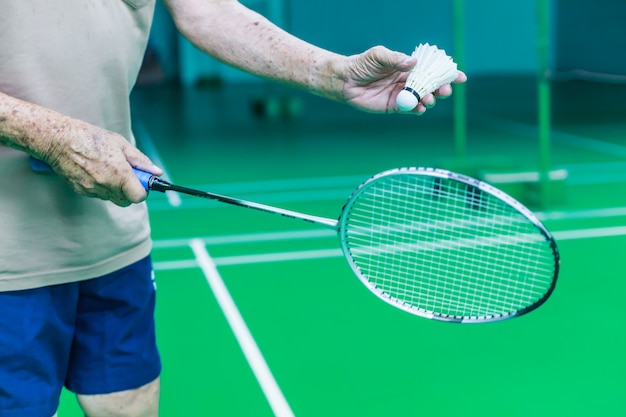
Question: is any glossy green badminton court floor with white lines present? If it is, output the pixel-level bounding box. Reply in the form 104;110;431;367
59;79;626;417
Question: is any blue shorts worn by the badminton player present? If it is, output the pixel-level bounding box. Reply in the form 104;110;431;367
0;257;161;417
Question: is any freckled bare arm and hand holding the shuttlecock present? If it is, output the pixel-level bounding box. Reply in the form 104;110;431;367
165;0;465;113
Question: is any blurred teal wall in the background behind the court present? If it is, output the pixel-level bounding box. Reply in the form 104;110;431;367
150;0;626;84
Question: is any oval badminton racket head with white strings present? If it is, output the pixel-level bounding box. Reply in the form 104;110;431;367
338;168;560;323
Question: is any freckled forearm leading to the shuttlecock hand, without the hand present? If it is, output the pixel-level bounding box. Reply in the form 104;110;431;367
166;0;347;99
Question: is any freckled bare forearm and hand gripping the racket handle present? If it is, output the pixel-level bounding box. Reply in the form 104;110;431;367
0;92;161;206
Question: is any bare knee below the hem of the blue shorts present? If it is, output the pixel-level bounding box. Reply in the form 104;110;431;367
77;378;161;417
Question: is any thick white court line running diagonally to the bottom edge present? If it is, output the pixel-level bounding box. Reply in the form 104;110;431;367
189;239;294;417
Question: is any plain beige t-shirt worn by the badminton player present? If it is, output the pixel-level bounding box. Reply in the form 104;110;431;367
0;0;154;291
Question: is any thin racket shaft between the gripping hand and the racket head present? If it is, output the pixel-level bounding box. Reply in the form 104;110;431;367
133;168;338;229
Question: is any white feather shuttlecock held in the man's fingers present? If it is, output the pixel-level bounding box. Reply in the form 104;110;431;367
396;43;459;111
